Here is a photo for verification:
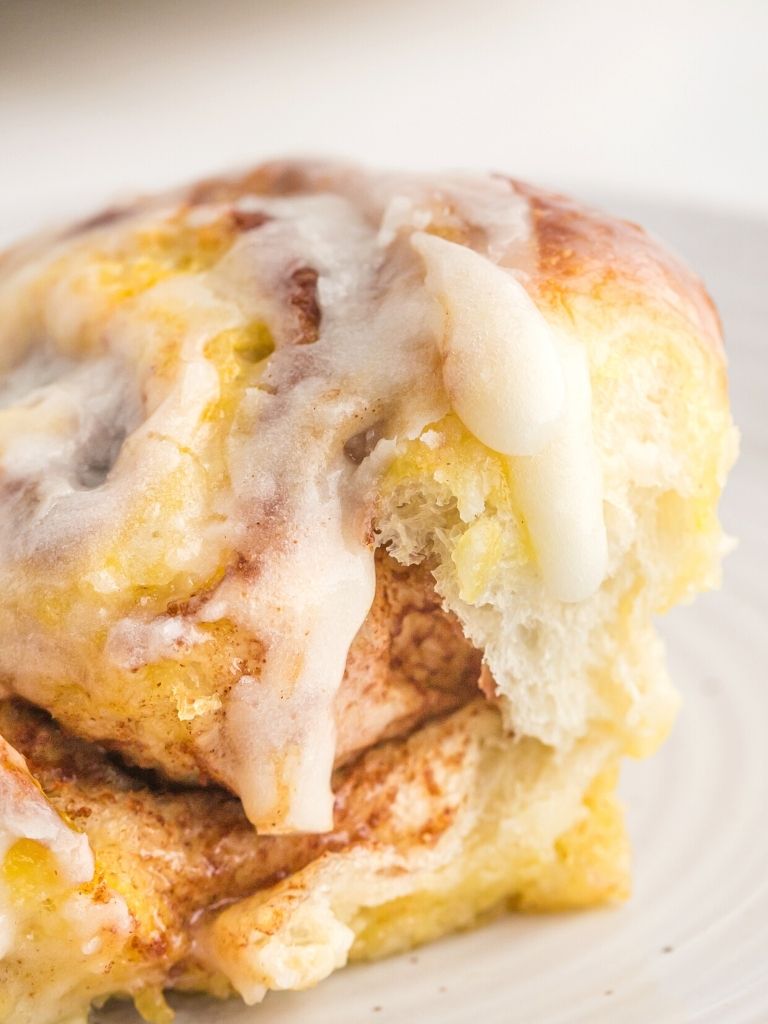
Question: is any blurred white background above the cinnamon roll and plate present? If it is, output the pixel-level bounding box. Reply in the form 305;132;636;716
0;0;768;241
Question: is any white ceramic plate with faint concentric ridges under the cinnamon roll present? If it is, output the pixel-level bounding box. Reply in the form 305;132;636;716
88;202;768;1024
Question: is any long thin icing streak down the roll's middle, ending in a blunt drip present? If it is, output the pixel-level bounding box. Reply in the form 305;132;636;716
204;197;445;831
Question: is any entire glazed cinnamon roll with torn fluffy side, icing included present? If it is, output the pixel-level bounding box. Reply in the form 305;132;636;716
0;163;736;1024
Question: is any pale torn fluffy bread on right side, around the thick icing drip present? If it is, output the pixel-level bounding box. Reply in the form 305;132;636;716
378;239;737;755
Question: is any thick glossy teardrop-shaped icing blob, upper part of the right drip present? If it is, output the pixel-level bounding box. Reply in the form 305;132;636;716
412;232;564;455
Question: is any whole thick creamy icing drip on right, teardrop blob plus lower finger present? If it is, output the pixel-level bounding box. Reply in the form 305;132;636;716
412;232;607;601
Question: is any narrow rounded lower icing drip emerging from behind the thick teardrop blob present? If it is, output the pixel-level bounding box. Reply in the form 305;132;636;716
511;339;607;601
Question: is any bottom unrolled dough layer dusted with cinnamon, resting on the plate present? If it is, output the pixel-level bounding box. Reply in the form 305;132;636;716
0;701;629;1024
